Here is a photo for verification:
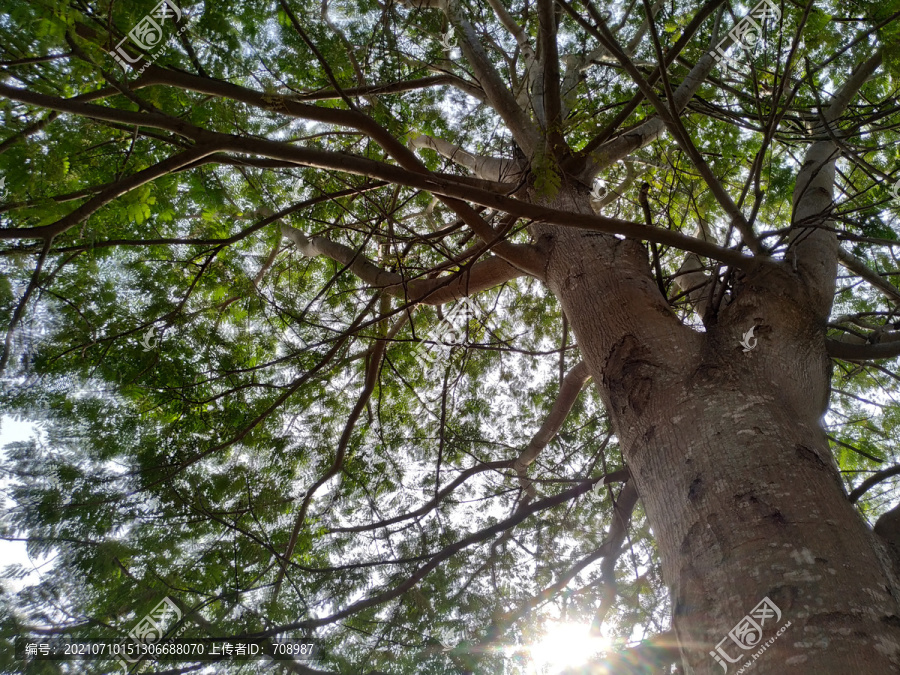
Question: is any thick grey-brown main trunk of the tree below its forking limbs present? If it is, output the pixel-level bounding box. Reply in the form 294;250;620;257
534;187;900;675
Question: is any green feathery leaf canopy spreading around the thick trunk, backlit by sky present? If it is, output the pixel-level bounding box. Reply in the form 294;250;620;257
0;0;900;673
